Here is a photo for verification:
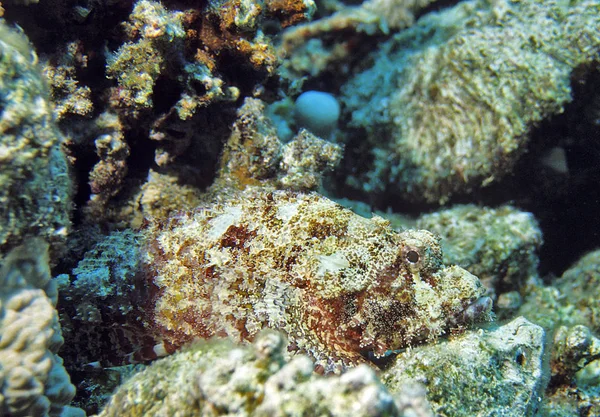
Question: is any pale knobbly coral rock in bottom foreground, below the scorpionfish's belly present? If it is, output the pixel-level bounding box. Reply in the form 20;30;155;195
99;332;432;417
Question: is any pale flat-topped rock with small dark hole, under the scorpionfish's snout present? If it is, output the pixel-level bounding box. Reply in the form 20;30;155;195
381;317;544;417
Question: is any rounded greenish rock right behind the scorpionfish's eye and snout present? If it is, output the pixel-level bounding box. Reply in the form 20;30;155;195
416;204;542;299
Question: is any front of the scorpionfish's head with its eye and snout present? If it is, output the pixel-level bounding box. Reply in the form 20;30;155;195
355;230;492;357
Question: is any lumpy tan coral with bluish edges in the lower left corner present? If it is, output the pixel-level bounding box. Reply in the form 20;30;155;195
0;240;84;417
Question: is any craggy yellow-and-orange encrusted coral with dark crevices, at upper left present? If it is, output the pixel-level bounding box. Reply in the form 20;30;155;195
15;0;315;228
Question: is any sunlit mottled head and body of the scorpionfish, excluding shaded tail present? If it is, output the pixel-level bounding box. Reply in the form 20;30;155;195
144;190;491;372
